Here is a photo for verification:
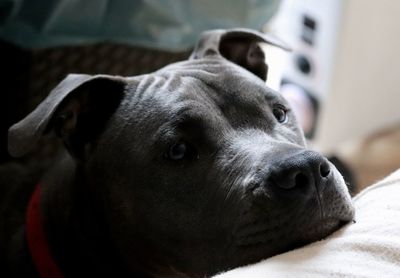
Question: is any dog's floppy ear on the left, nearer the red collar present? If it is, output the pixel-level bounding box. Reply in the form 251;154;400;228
8;74;125;158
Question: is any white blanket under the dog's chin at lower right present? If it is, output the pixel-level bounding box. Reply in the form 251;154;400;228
216;169;400;278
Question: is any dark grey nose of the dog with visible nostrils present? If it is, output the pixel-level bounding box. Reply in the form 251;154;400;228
266;151;331;189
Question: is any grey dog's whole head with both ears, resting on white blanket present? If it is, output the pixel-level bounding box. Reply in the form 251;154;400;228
9;30;353;275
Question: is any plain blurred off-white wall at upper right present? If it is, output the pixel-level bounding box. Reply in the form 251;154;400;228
315;0;400;151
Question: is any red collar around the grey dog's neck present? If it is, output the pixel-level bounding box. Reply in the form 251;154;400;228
25;185;64;278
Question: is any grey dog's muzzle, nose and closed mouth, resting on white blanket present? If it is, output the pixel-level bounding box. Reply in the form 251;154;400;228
230;149;354;258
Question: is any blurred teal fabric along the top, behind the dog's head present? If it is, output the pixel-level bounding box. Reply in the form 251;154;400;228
0;0;280;51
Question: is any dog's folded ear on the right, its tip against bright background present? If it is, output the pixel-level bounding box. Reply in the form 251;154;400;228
190;28;290;81
